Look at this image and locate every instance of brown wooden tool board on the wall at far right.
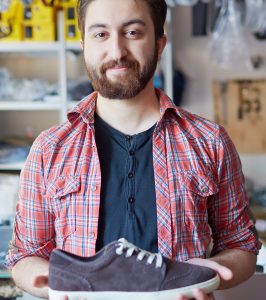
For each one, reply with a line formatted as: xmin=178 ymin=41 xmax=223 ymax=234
xmin=213 ymin=79 xmax=266 ymax=154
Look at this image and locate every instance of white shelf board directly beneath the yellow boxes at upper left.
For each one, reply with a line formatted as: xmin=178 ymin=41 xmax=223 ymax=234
xmin=0 ymin=41 xmax=59 ymax=53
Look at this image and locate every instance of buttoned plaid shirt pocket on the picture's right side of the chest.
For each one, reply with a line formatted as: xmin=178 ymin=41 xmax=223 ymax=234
xmin=179 ymin=172 xmax=218 ymax=235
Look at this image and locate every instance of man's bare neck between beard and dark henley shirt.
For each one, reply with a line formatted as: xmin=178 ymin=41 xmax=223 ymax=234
xmin=96 ymin=85 xmax=160 ymax=135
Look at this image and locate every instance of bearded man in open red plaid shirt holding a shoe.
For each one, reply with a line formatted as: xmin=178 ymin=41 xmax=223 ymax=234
xmin=5 ymin=0 xmax=259 ymax=299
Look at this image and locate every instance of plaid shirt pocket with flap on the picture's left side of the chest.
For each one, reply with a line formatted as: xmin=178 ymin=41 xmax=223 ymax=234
xmin=46 ymin=175 xmax=81 ymax=243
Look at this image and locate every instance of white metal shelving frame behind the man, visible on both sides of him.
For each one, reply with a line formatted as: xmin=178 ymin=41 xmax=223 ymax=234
xmin=0 ymin=8 xmax=173 ymax=172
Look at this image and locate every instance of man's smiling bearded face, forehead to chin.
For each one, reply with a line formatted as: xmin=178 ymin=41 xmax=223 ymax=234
xmin=83 ymin=0 xmax=162 ymax=99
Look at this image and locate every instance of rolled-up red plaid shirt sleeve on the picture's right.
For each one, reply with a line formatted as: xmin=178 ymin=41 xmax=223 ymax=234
xmin=209 ymin=127 xmax=261 ymax=255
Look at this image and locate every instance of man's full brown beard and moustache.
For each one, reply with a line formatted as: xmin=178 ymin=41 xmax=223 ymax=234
xmin=85 ymin=46 xmax=158 ymax=99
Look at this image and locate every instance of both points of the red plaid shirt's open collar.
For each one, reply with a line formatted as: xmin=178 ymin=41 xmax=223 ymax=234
xmin=67 ymin=88 xmax=183 ymax=124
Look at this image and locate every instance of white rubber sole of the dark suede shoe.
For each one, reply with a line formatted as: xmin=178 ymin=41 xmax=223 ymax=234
xmin=49 ymin=275 xmax=220 ymax=300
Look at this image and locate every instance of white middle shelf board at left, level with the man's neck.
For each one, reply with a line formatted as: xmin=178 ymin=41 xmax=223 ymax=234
xmin=0 ymin=101 xmax=62 ymax=111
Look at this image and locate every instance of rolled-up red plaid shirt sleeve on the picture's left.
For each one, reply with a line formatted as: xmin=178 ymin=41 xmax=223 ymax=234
xmin=6 ymin=133 xmax=55 ymax=268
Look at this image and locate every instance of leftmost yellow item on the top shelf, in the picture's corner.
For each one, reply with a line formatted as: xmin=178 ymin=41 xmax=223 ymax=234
xmin=0 ymin=0 xmax=23 ymax=42
